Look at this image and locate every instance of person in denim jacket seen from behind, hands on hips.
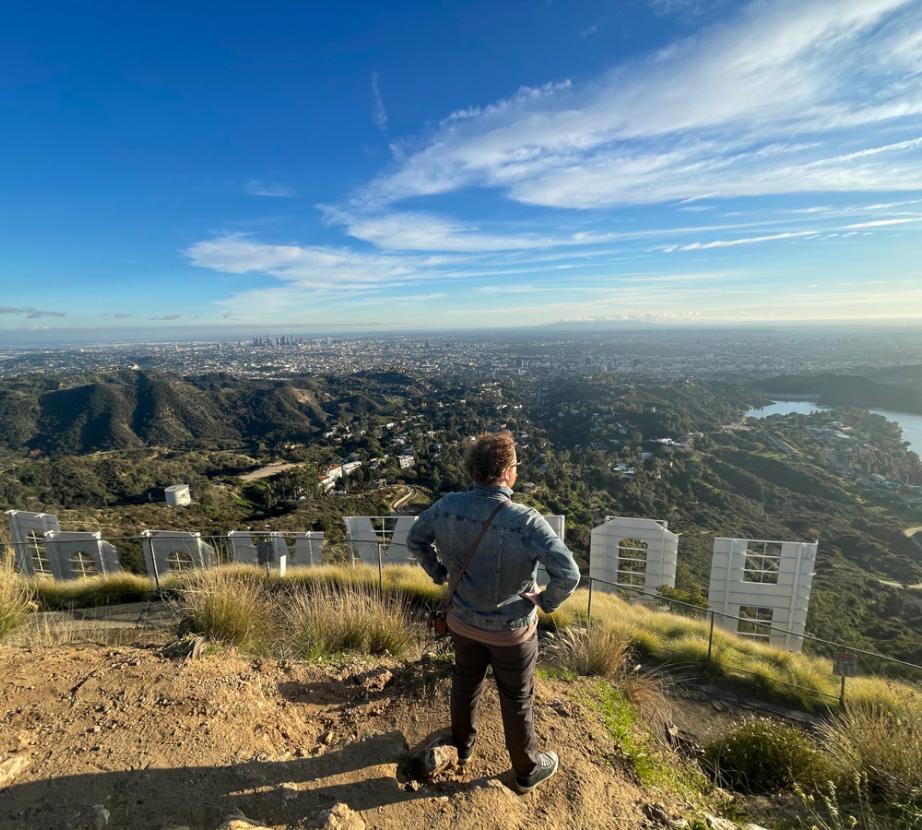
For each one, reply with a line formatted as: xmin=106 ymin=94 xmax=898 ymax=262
xmin=407 ymin=432 xmax=579 ymax=793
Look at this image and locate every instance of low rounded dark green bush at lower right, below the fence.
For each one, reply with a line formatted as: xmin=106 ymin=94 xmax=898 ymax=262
xmin=705 ymin=718 xmax=833 ymax=793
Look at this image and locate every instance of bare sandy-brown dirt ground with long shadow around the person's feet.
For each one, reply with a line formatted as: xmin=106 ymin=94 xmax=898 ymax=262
xmin=0 ymin=645 xmax=682 ymax=830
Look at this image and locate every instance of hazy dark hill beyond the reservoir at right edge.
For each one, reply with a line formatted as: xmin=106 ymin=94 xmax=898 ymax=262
xmin=759 ymin=366 xmax=922 ymax=415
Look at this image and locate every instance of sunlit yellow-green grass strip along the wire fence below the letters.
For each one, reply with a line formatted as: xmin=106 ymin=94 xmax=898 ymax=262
xmin=16 ymin=564 xmax=918 ymax=711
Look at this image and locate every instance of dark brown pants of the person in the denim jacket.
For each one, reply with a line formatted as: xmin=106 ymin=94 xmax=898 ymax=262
xmin=451 ymin=631 xmax=539 ymax=778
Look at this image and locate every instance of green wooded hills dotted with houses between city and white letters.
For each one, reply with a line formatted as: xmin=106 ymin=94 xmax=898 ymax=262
xmin=0 ymin=370 xmax=922 ymax=663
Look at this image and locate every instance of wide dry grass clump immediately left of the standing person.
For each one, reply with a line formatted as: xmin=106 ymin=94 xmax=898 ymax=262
xmin=285 ymin=587 xmax=416 ymax=660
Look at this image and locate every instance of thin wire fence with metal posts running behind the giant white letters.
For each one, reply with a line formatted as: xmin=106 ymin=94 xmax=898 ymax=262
xmin=7 ymin=532 xmax=922 ymax=703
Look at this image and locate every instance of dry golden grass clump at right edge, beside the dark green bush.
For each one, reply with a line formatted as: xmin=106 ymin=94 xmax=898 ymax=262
xmin=823 ymin=703 xmax=922 ymax=805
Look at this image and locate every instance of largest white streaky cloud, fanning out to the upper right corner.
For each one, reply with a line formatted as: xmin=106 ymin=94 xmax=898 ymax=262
xmin=358 ymin=0 xmax=922 ymax=208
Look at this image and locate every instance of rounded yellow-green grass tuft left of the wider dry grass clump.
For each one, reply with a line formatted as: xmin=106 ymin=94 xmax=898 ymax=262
xmin=177 ymin=570 xmax=274 ymax=650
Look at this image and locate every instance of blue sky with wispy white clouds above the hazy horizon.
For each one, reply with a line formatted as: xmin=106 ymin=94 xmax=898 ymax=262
xmin=0 ymin=0 xmax=922 ymax=336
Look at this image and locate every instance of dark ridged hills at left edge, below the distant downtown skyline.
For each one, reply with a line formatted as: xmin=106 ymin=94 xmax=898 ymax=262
xmin=0 ymin=372 xmax=344 ymax=455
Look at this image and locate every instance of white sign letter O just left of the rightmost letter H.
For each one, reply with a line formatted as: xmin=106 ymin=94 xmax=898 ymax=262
xmin=589 ymin=516 xmax=679 ymax=594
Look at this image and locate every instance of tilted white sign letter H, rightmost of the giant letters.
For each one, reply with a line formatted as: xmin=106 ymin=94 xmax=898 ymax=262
xmin=708 ymin=537 xmax=818 ymax=652
